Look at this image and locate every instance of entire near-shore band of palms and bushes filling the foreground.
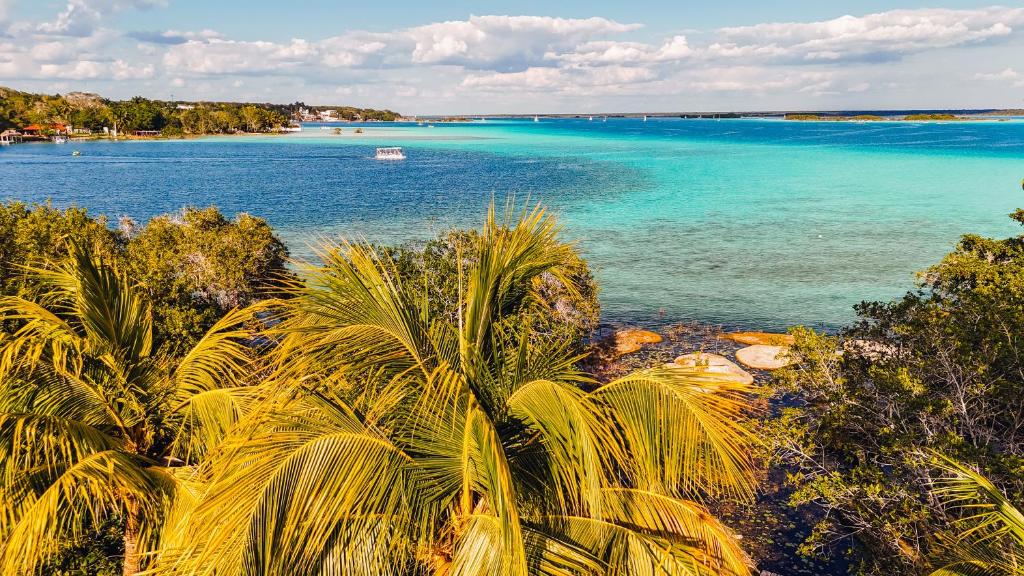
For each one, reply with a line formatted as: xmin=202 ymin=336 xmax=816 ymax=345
xmin=0 ymin=196 xmax=1024 ymax=576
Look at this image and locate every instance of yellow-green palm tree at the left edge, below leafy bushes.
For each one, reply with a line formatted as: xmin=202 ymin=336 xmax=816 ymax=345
xmin=0 ymin=243 xmax=250 ymax=576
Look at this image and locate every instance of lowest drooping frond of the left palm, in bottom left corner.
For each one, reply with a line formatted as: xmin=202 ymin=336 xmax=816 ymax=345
xmin=0 ymin=450 xmax=166 ymax=576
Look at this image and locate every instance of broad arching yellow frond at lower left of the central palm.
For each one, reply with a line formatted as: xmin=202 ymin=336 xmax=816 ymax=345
xmin=157 ymin=387 xmax=422 ymax=576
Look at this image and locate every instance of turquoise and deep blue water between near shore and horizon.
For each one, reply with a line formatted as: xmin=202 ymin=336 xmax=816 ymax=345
xmin=0 ymin=119 xmax=1024 ymax=329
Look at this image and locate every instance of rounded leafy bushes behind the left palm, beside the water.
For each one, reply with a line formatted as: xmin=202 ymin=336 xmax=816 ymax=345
xmin=0 ymin=202 xmax=292 ymax=349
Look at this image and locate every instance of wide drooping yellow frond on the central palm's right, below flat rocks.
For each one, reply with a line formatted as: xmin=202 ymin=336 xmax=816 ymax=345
xmin=591 ymin=368 xmax=756 ymax=498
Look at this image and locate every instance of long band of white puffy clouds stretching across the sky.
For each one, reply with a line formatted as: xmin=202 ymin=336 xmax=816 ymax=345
xmin=0 ymin=0 xmax=1024 ymax=109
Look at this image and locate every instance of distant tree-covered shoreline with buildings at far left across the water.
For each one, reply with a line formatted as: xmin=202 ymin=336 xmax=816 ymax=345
xmin=0 ymin=87 xmax=397 ymax=136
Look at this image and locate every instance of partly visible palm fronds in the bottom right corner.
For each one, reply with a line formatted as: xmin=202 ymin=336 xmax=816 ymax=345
xmin=932 ymin=455 xmax=1024 ymax=576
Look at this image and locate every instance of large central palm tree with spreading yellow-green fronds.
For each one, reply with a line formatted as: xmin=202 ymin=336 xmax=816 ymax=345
xmin=157 ymin=203 xmax=754 ymax=576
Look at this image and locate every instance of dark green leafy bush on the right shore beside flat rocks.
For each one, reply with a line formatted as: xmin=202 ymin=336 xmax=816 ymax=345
xmin=777 ymin=211 xmax=1024 ymax=575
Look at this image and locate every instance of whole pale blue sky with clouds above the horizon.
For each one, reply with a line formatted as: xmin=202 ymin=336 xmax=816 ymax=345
xmin=0 ymin=0 xmax=1024 ymax=115
